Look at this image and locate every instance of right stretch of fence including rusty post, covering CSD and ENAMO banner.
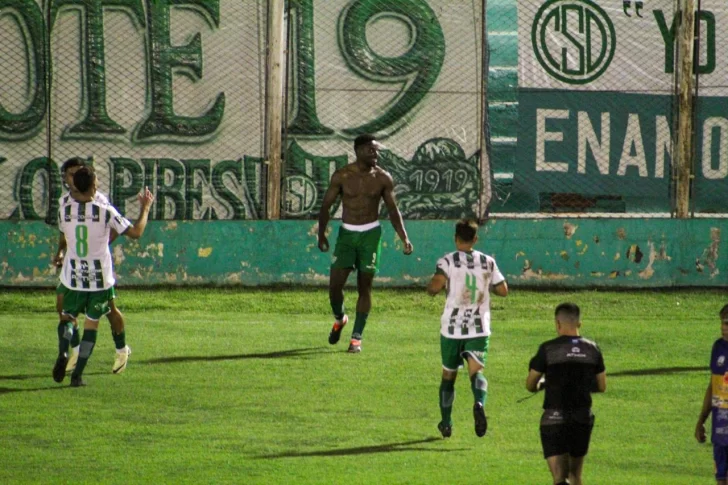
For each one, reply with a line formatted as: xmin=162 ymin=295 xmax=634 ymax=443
xmin=487 ymin=0 xmax=728 ymax=217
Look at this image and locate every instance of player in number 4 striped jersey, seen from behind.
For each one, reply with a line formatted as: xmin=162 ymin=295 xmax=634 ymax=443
xmin=427 ymin=220 xmax=508 ymax=438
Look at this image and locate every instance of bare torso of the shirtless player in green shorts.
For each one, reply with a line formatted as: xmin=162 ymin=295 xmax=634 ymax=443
xmin=337 ymin=163 xmax=391 ymax=225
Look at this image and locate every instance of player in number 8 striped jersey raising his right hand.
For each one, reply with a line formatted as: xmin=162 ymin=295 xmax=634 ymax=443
xmin=53 ymin=167 xmax=154 ymax=387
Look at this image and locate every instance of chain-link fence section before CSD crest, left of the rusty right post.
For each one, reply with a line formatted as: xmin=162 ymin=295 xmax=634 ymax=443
xmin=487 ymin=0 xmax=679 ymax=215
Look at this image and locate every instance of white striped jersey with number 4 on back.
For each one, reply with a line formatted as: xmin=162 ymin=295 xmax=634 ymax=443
xmin=437 ymin=251 xmax=505 ymax=339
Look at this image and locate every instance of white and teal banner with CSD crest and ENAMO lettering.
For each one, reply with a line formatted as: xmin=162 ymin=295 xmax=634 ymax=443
xmin=513 ymin=0 xmax=728 ymax=213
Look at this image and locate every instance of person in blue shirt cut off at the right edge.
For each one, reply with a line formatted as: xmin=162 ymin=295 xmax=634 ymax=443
xmin=695 ymin=305 xmax=728 ymax=485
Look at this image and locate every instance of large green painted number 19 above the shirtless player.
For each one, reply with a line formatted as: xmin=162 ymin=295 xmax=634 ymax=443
xmin=288 ymin=0 xmax=445 ymax=136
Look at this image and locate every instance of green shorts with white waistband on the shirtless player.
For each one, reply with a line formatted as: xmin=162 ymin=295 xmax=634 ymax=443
xmin=331 ymin=226 xmax=382 ymax=274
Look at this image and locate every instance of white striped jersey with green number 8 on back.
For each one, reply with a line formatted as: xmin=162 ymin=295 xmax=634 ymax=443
xmin=58 ymin=197 xmax=131 ymax=291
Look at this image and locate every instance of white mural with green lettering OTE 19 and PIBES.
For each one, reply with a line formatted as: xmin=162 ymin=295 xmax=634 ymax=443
xmin=0 ymin=0 xmax=481 ymax=220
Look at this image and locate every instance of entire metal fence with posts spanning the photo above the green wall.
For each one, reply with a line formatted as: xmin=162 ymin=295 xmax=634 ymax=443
xmin=0 ymin=0 xmax=728 ymax=221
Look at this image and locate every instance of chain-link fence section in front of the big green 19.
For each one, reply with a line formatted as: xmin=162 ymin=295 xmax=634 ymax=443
xmin=282 ymin=0 xmax=483 ymax=219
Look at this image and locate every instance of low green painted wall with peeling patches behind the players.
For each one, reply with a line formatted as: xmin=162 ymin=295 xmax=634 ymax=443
xmin=0 ymin=219 xmax=728 ymax=288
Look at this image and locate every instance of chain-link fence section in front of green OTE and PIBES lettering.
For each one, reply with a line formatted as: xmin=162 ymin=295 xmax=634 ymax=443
xmin=0 ymin=1 xmax=267 ymax=221
